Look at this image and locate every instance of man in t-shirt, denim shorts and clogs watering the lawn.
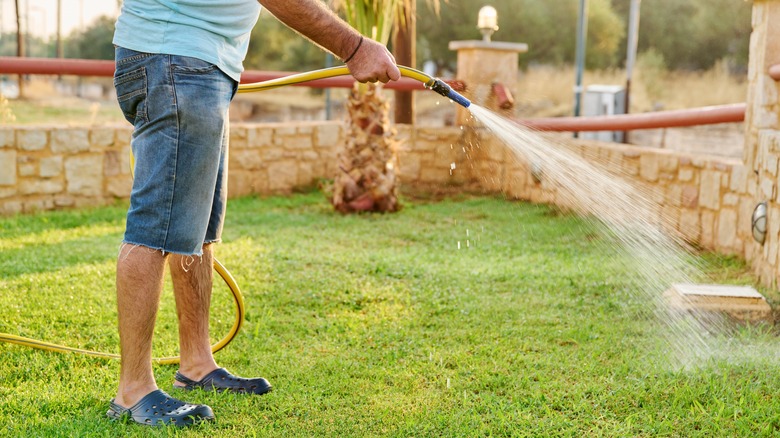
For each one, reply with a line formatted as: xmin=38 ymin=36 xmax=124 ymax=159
xmin=107 ymin=0 xmax=400 ymax=425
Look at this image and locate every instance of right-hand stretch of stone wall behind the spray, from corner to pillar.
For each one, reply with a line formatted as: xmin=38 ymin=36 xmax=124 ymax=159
xmin=475 ymin=132 xmax=755 ymax=257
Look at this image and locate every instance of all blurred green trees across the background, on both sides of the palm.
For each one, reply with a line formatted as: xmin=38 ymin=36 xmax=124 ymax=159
xmin=0 ymin=0 xmax=752 ymax=72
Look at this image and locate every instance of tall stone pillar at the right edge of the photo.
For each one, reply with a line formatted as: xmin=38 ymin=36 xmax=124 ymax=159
xmin=744 ymin=0 xmax=780 ymax=287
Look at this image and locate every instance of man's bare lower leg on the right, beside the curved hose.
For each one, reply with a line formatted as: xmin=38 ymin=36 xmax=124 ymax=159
xmin=169 ymin=245 xmax=219 ymax=386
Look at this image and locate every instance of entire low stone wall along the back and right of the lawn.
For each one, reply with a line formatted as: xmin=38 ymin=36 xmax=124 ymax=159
xmin=0 ymin=122 xmax=756 ymax=258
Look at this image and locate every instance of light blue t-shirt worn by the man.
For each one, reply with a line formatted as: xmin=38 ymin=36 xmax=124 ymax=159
xmin=114 ymin=0 xmax=260 ymax=81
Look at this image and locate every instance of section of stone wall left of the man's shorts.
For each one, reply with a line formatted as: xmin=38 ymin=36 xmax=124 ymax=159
xmin=0 ymin=126 xmax=131 ymax=215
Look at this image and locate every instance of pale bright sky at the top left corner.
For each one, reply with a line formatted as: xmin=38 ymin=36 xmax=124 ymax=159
xmin=0 ymin=0 xmax=118 ymax=37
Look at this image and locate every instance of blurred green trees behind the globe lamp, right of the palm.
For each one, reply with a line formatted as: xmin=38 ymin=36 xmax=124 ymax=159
xmin=417 ymin=0 xmax=752 ymax=69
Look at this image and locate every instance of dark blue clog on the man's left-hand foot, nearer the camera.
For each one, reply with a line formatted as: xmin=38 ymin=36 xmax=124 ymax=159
xmin=106 ymin=389 xmax=214 ymax=426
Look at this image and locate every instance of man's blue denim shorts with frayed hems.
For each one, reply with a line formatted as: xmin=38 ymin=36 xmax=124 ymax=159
xmin=114 ymin=47 xmax=238 ymax=255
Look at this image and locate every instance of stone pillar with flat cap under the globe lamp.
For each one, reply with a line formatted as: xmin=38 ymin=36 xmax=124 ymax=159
xmin=449 ymin=40 xmax=528 ymax=125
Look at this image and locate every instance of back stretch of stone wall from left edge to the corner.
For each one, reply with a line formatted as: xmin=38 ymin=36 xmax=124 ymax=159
xmin=0 ymin=122 xmax=470 ymax=215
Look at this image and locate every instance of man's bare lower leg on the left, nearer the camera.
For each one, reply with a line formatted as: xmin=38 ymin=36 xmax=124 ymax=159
xmin=114 ymin=244 xmax=166 ymax=408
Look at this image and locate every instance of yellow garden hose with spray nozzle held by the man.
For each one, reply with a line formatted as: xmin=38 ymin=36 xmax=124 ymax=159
xmin=0 ymin=65 xmax=471 ymax=364
